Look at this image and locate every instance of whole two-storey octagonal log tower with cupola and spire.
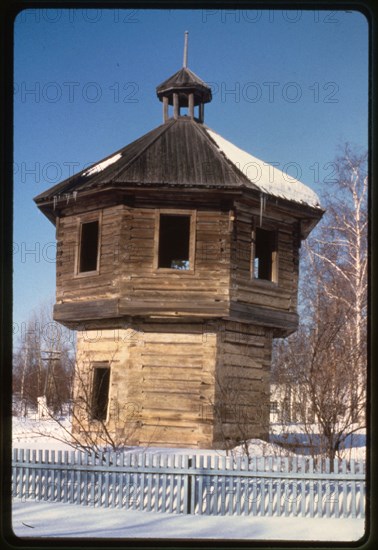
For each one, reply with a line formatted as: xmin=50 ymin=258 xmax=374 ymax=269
xmin=35 ymin=34 xmax=322 ymax=448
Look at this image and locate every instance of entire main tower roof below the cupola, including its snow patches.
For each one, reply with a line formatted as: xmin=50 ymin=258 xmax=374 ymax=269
xmin=34 ymin=117 xmax=320 ymax=219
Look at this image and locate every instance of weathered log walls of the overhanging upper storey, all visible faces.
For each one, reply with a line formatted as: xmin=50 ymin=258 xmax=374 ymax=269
xmin=55 ymin=203 xmax=298 ymax=334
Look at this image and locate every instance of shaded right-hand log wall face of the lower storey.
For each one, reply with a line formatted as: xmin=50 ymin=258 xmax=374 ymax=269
xmin=214 ymin=321 xmax=272 ymax=448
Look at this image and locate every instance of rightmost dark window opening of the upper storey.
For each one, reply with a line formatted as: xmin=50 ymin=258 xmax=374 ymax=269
xmin=252 ymin=228 xmax=277 ymax=282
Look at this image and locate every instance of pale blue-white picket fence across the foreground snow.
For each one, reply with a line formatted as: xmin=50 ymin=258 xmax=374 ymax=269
xmin=12 ymin=449 xmax=365 ymax=518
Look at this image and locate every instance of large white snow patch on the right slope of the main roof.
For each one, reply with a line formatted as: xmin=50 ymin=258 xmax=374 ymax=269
xmin=206 ymin=128 xmax=320 ymax=208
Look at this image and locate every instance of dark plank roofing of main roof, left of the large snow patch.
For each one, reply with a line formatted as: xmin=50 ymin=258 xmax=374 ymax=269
xmin=34 ymin=117 xmax=258 ymax=204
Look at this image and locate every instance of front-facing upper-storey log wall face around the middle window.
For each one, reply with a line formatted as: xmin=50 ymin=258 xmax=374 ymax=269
xmin=120 ymin=208 xmax=229 ymax=315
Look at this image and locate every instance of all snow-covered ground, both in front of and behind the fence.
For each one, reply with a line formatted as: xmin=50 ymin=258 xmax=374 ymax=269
xmin=12 ymin=417 xmax=365 ymax=541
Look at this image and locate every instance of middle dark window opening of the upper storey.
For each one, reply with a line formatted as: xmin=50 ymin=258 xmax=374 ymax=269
xmin=158 ymin=214 xmax=190 ymax=270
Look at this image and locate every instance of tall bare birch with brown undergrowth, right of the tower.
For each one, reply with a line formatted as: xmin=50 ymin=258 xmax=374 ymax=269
xmin=274 ymin=145 xmax=368 ymax=459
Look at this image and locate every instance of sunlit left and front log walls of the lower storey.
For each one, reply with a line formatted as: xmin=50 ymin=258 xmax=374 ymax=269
xmin=73 ymin=323 xmax=216 ymax=448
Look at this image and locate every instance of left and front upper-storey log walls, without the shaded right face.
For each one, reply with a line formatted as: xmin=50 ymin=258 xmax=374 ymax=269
xmin=56 ymin=205 xmax=230 ymax=321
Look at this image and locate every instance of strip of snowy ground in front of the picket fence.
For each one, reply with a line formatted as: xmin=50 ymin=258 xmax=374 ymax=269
xmin=13 ymin=499 xmax=364 ymax=541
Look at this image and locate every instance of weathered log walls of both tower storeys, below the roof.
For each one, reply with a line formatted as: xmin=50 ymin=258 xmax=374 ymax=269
xmin=54 ymin=197 xmax=308 ymax=448
